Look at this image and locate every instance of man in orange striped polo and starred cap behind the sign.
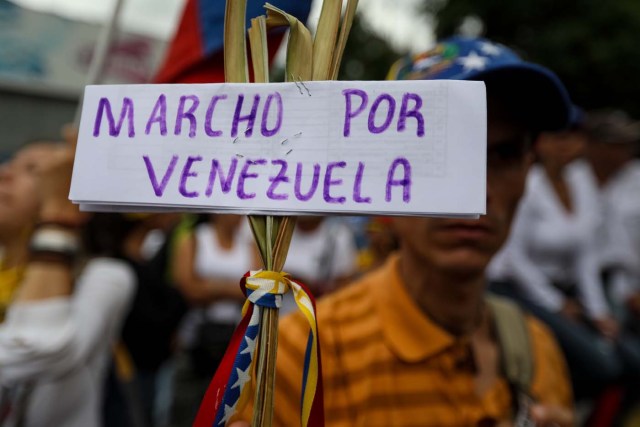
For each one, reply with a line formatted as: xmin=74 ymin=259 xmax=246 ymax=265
xmin=232 ymin=38 xmax=573 ymax=427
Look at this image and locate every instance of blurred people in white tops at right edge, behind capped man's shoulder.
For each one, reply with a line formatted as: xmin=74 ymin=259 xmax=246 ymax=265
xmin=487 ymin=110 xmax=640 ymax=425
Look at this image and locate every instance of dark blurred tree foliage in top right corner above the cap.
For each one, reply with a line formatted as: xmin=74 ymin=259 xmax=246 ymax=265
xmin=424 ymin=0 xmax=640 ymax=118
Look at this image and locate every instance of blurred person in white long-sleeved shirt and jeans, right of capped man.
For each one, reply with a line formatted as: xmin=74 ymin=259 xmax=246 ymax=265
xmin=488 ymin=130 xmax=622 ymax=397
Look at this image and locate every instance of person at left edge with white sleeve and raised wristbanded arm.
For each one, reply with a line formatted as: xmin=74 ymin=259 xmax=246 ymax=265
xmin=0 ymin=143 xmax=135 ymax=427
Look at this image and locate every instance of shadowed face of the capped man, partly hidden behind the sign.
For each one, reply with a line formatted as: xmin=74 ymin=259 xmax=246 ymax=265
xmin=394 ymin=109 xmax=532 ymax=275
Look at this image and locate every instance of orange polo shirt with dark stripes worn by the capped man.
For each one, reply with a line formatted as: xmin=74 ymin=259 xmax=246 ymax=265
xmin=234 ymin=257 xmax=571 ymax=427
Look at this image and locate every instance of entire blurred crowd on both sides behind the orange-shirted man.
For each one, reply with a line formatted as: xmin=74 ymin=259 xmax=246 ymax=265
xmin=0 ymin=44 xmax=640 ymax=427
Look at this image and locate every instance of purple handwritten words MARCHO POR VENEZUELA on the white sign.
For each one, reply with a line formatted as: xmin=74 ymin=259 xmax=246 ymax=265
xmin=93 ymin=89 xmax=425 ymax=204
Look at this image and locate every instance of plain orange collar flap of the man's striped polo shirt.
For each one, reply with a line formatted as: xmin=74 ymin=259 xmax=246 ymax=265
xmin=373 ymin=255 xmax=456 ymax=362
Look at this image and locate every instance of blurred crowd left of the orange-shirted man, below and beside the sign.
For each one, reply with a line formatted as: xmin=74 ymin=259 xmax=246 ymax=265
xmin=0 ymin=137 xmax=370 ymax=426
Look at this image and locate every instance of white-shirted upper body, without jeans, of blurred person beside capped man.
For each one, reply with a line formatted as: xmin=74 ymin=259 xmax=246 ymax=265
xmin=492 ymin=129 xmax=616 ymax=322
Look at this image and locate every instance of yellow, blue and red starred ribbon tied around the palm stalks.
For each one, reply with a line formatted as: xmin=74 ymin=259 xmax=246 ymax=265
xmin=193 ymin=270 xmax=324 ymax=427
